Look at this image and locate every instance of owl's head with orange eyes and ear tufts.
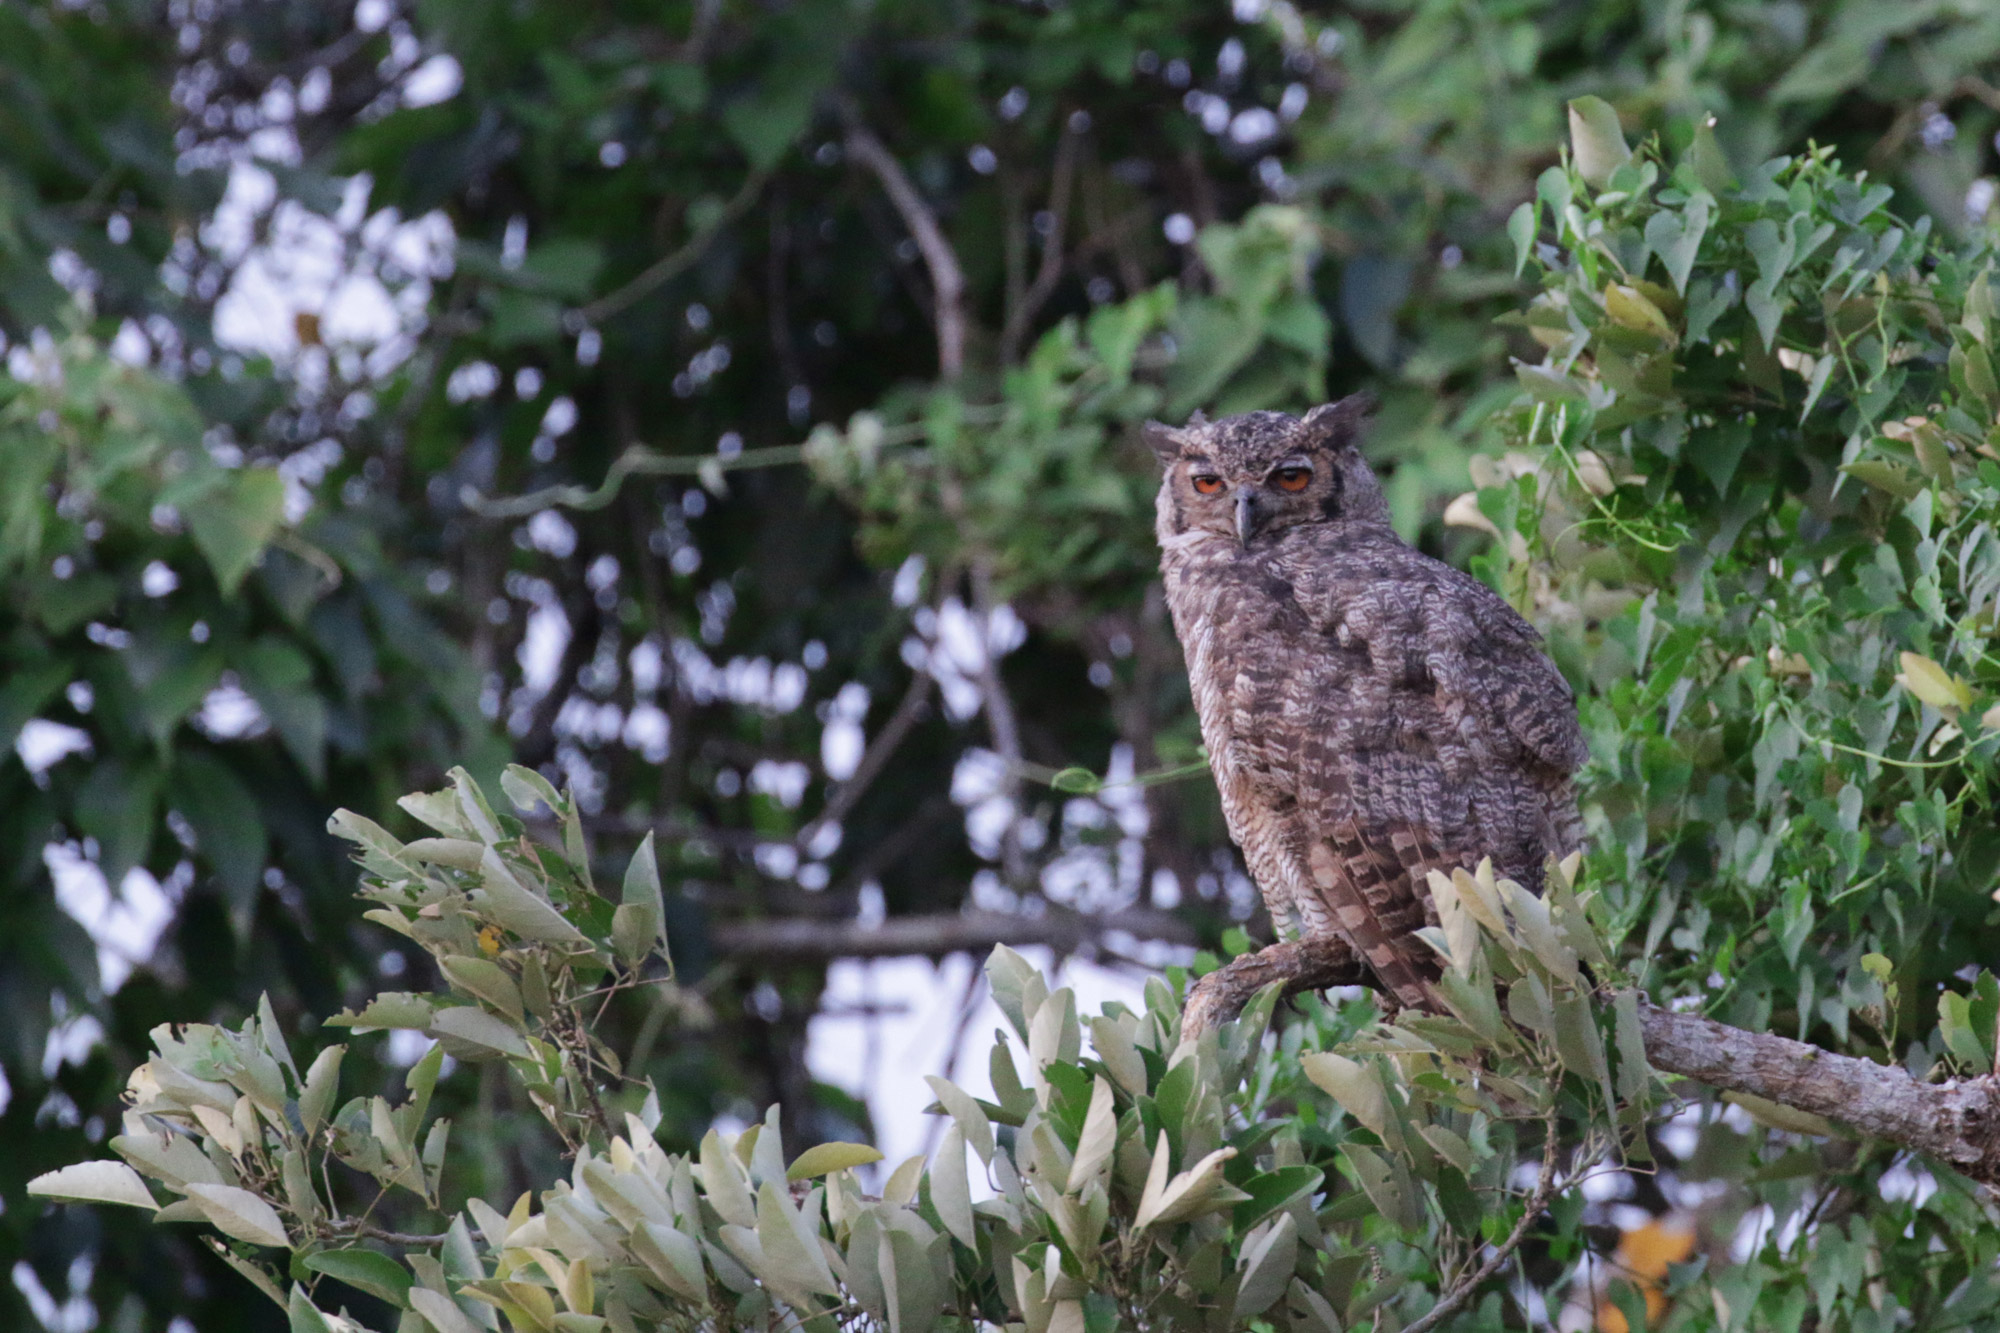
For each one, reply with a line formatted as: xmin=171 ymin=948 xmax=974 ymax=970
xmin=1146 ymin=394 xmax=1388 ymax=548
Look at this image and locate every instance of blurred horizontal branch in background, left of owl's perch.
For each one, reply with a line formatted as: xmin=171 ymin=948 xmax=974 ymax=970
xmin=714 ymin=909 xmax=1196 ymax=963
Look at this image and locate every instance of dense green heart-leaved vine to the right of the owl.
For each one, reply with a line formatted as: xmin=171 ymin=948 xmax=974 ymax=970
xmin=1454 ymin=100 xmax=2000 ymax=1329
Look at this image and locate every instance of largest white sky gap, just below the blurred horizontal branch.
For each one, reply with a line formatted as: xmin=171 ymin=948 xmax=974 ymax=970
xmin=806 ymin=949 xmax=1146 ymax=1199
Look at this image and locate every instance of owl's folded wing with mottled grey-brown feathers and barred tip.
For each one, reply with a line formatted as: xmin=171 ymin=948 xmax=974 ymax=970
xmin=1290 ymin=538 xmax=1586 ymax=1007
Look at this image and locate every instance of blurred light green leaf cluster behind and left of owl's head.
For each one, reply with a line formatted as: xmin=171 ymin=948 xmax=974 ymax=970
xmin=808 ymin=204 xmax=1328 ymax=618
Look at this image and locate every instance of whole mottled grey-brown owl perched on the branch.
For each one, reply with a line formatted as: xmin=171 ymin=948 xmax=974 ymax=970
xmin=1146 ymin=398 xmax=1586 ymax=1009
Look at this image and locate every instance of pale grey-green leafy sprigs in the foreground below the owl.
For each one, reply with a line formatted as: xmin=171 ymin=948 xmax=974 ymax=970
xmin=30 ymin=767 xmax=1650 ymax=1333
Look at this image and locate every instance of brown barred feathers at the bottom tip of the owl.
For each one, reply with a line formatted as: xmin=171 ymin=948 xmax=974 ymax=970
xmin=1310 ymin=819 xmax=1460 ymax=1013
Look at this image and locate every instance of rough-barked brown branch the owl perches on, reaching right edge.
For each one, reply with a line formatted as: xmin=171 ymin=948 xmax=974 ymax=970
xmin=1184 ymin=939 xmax=2000 ymax=1185
